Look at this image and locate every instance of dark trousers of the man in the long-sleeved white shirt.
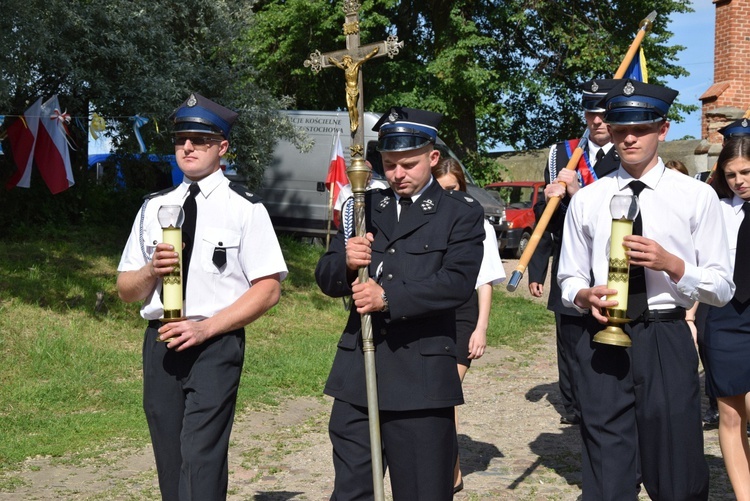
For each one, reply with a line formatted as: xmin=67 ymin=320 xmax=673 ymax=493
xmin=576 ymin=316 xmax=708 ymax=501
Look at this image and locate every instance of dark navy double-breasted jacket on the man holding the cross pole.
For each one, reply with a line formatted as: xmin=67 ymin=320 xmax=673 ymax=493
xmin=315 ymin=180 xmax=485 ymax=411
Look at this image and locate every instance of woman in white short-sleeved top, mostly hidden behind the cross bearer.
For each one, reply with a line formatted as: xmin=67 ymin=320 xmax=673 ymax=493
xmin=432 ymin=156 xmax=505 ymax=493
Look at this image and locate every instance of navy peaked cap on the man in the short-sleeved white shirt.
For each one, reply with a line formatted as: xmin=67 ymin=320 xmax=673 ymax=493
xmin=170 ymin=93 xmax=237 ymax=139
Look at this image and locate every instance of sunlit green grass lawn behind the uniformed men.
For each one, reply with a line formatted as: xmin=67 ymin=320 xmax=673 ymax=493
xmin=0 ymin=228 xmax=554 ymax=472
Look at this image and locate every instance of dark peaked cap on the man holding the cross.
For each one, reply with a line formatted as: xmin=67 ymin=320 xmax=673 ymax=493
xmin=372 ymin=106 xmax=443 ymax=151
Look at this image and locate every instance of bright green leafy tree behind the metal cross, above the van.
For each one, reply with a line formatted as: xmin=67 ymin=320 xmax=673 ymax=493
xmin=245 ymin=0 xmax=690 ymax=172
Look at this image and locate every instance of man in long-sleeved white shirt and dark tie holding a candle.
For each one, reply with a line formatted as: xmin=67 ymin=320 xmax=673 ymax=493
xmin=557 ymin=79 xmax=734 ymax=501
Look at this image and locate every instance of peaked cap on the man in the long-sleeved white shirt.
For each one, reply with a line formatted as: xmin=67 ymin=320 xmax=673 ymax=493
xmin=599 ymin=78 xmax=679 ymax=125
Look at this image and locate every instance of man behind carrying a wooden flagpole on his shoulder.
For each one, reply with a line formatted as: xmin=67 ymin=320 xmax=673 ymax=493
xmin=529 ymin=79 xmax=620 ymax=424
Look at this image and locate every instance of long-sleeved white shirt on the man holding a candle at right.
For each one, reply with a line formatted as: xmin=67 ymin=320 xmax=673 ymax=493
xmin=557 ymin=159 xmax=734 ymax=312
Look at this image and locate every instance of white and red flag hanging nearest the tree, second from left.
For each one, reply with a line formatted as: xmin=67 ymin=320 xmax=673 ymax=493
xmin=34 ymin=95 xmax=75 ymax=195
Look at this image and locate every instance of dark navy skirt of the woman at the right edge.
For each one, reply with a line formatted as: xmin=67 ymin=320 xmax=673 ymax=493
xmin=703 ymin=299 xmax=750 ymax=397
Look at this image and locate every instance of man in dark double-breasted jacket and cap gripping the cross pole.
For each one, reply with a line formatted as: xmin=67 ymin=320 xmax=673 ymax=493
xmin=315 ymin=107 xmax=485 ymax=501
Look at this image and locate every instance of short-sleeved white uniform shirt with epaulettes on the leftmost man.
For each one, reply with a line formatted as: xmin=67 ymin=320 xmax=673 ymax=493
xmin=117 ymin=170 xmax=287 ymax=320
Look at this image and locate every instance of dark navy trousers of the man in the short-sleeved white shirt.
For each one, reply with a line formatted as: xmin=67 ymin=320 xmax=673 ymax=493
xmin=143 ymin=320 xmax=245 ymax=501
